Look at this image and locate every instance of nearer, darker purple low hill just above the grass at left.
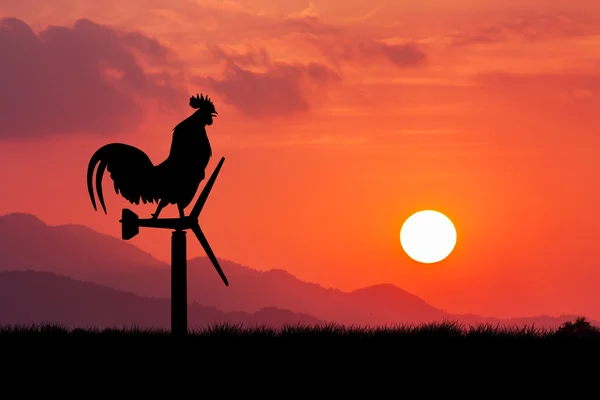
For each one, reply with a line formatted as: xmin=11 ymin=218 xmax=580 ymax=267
xmin=0 ymin=271 xmax=323 ymax=329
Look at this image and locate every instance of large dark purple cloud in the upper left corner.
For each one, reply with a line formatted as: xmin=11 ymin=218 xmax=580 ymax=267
xmin=0 ymin=18 xmax=186 ymax=138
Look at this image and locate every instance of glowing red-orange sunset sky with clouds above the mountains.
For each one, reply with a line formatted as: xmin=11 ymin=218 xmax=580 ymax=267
xmin=0 ymin=0 xmax=600 ymax=319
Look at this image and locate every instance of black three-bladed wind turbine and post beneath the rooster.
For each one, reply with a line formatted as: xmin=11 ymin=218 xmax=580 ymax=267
xmin=119 ymin=157 xmax=229 ymax=336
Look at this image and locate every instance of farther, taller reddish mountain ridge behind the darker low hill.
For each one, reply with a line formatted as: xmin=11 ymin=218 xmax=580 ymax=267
xmin=0 ymin=213 xmax=592 ymax=327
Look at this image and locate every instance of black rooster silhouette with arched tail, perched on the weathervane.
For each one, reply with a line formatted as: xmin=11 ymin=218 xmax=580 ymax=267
xmin=87 ymin=94 xmax=218 ymax=219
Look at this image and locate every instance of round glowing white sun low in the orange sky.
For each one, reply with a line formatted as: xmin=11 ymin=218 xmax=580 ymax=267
xmin=400 ymin=210 xmax=456 ymax=264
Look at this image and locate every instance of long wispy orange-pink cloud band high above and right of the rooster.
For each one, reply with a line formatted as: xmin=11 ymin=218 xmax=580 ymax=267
xmin=177 ymin=12 xmax=428 ymax=70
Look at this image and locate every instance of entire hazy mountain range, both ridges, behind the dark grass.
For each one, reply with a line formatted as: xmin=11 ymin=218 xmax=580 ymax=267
xmin=0 ymin=213 xmax=592 ymax=327
